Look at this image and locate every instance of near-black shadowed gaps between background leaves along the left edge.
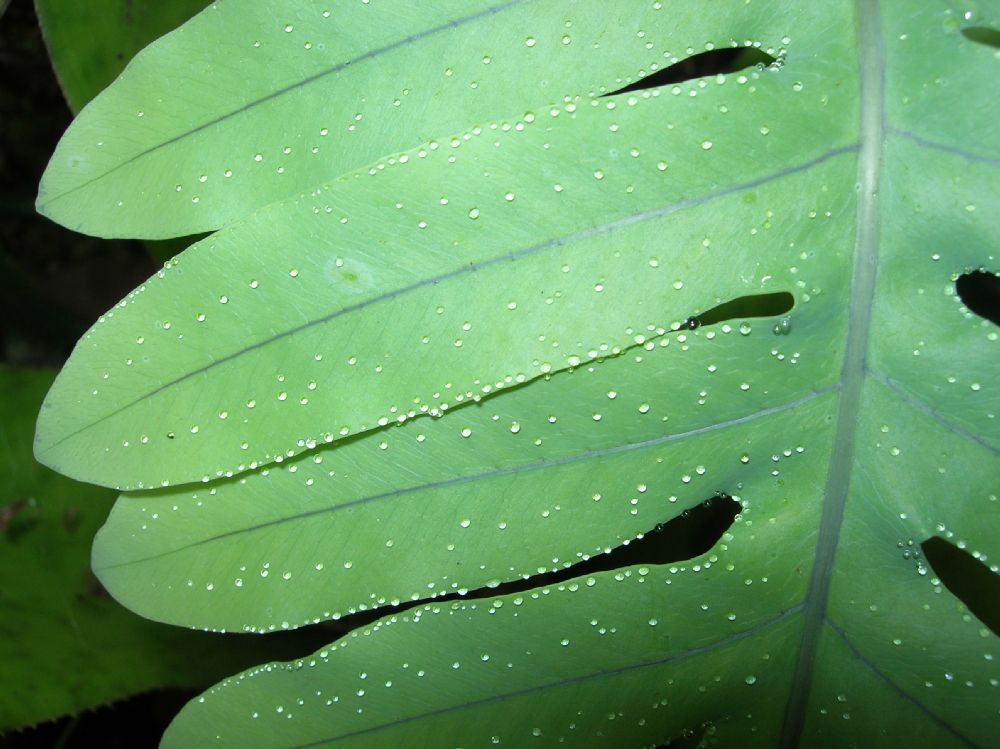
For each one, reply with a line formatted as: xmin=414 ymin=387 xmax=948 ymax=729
xmin=0 ymin=0 xmax=179 ymax=749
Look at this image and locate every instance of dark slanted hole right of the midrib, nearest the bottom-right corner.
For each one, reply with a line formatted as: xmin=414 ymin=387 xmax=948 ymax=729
xmin=920 ymin=536 xmax=1000 ymax=635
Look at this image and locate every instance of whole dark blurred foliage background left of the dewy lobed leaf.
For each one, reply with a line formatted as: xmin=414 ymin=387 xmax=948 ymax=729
xmin=0 ymin=0 xmax=310 ymax=749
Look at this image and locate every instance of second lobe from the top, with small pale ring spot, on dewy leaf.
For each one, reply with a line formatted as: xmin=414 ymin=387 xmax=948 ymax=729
xmin=37 ymin=2 xmax=854 ymax=489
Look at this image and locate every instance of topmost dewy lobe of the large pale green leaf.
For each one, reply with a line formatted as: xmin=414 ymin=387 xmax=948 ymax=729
xmin=38 ymin=0 xmax=780 ymax=239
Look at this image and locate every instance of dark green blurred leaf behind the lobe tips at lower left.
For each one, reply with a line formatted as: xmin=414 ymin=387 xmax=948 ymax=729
xmin=0 ymin=368 xmax=320 ymax=731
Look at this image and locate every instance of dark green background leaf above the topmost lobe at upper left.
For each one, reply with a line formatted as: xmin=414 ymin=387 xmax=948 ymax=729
xmin=33 ymin=0 xmax=208 ymax=112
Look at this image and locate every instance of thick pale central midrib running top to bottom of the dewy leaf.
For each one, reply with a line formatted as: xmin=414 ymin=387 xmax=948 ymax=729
xmin=781 ymin=0 xmax=885 ymax=749
